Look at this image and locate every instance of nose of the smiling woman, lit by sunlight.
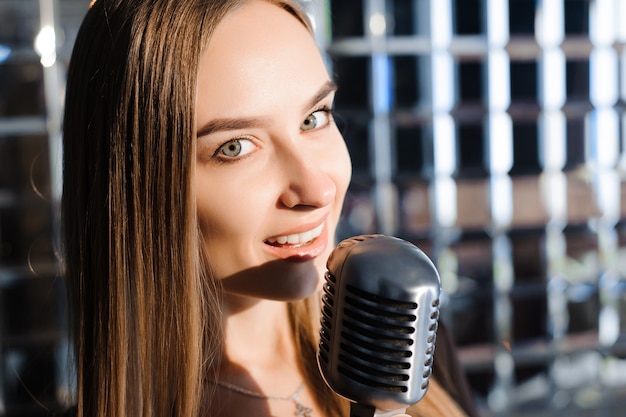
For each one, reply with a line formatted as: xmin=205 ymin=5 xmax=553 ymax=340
xmin=279 ymin=151 xmax=337 ymax=208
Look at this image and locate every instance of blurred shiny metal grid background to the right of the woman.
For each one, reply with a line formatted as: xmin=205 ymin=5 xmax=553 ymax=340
xmin=318 ymin=0 xmax=626 ymax=415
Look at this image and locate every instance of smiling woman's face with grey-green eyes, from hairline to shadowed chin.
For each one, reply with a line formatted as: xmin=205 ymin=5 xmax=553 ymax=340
xmin=195 ymin=1 xmax=351 ymax=300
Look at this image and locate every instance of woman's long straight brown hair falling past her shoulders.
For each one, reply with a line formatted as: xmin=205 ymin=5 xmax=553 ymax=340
xmin=62 ymin=0 xmax=343 ymax=417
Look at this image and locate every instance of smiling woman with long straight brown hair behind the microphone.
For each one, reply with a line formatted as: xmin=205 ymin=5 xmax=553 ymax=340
xmin=63 ymin=0 xmax=471 ymax=417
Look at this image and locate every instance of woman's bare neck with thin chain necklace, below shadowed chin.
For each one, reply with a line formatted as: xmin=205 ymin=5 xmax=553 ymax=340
xmin=210 ymin=296 xmax=323 ymax=417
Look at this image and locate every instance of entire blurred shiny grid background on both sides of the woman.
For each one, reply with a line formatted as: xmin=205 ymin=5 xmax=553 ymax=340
xmin=0 ymin=0 xmax=626 ymax=417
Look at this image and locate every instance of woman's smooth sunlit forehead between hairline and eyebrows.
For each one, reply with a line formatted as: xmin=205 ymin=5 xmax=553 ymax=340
xmin=198 ymin=0 xmax=329 ymax=117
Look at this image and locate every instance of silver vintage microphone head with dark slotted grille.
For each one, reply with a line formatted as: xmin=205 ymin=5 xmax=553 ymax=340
xmin=317 ymin=235 xmax=441 ymax=410
